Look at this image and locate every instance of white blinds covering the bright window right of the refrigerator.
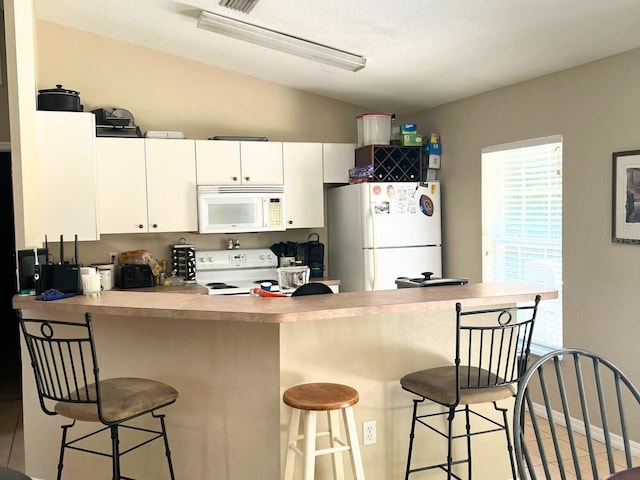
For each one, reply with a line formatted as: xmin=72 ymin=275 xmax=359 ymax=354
xmin=482 ymin=136 xmax=562 ymax=354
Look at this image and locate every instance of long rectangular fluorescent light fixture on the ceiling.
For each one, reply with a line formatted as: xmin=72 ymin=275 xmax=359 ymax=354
xmin=198 ymin=10 xmax=367 ymax=72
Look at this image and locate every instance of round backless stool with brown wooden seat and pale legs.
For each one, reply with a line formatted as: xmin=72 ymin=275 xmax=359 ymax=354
xmin=282 ymin=383 xmax=364 ymax=480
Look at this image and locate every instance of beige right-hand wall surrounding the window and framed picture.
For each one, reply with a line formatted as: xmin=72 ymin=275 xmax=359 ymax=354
xmin=415 ymin=50 xmax=640 ymax=384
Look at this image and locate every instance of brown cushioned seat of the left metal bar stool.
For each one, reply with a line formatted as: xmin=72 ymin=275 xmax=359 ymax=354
xmin=55 ymin=378 xmax=178 ymax=423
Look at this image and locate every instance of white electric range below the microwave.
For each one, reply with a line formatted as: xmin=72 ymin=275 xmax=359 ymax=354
xmin=196 ymin=248 xmax=278 ymax=296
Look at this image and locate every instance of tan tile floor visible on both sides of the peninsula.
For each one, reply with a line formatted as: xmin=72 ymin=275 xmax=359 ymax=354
xmin=0 ymin=400 xmax=640 ymax=480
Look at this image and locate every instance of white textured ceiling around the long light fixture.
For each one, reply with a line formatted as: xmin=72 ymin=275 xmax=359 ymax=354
xmin=34 ymin=0 xmax=640 ymax=114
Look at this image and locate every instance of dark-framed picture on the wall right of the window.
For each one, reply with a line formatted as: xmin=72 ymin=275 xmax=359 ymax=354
xmin=611 ymin=150 xmax=640 ymax=244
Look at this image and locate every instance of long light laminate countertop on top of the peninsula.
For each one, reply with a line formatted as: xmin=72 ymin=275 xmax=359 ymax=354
xmin=13 ymin=283 xmax=558 ymax=323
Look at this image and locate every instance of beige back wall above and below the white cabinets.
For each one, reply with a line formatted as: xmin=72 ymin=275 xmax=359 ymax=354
xmin=25 ymin=21 xmax=366 ymax=264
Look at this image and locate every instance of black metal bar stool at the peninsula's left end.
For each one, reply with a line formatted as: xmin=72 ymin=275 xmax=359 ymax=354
xmin=18 ymin=311 xmax=178 ymax=480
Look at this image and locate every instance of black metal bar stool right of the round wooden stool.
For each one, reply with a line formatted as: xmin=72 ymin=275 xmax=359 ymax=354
xmin=400 ymin=295 xmax=540 ymax=480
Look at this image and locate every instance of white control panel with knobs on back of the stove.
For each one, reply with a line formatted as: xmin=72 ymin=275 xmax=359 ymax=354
xmin=196 ymin=248 xmax=278 ymax=271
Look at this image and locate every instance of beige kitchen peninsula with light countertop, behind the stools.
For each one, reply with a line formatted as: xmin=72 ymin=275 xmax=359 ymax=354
xmin=13 ymin=284 xmax=557 ymax=480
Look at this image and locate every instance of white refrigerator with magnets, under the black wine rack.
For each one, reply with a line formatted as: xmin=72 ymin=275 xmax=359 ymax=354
xmin=327 ymin=181 xmax=442 ymax=292
